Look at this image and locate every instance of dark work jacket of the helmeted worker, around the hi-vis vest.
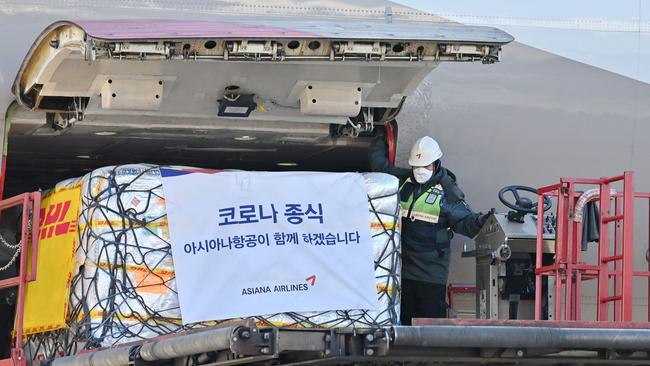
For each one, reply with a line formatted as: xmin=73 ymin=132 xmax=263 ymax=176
xmin=369 ymin=140 xmax=481 ymax=285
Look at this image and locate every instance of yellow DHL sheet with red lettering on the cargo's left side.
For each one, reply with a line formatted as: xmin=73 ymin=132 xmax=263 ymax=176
xmin=24 ymin=183 xmax=81 ymax=334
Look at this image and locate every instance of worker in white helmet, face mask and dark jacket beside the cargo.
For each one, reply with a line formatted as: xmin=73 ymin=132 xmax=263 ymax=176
xmin=369 ymin=126 xmax=494 ymax=325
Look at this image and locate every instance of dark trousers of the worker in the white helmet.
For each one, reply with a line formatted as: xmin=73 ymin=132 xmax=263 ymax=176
xmin=400 ymin=278 xmax=447 ymax=325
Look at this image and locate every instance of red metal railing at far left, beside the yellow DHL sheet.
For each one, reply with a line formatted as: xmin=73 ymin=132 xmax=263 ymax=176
xmin=0 ymin=192 xmax=41 ymax=366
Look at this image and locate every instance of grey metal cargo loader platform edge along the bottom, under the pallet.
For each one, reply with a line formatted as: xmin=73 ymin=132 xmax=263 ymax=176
xmin=43 ymin=319 xmax=650 ymax=366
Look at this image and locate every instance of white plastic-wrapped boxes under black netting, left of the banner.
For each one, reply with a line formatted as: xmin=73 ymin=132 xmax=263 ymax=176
xmin=71 ymin=165 xmax=180 ymax=345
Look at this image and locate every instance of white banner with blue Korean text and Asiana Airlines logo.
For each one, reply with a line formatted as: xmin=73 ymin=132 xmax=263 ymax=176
xmin=161 ymin=169 xmax=379 ymax=324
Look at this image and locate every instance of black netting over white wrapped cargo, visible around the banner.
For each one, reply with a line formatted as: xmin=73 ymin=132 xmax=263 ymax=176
xmin=28 ymin=164 xmax=401 ymax=358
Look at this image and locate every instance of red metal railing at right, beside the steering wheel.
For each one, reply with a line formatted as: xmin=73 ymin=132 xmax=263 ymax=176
xmin=535 ymin=172 xmax=650 ymax=322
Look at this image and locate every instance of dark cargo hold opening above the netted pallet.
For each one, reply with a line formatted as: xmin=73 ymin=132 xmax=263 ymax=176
xmin=4 ymin=103 xmax=371 ymax=197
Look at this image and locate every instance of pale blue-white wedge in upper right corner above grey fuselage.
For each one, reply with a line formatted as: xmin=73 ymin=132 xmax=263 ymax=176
xmin=397 ymin=0 xmax=650 ymax=83
